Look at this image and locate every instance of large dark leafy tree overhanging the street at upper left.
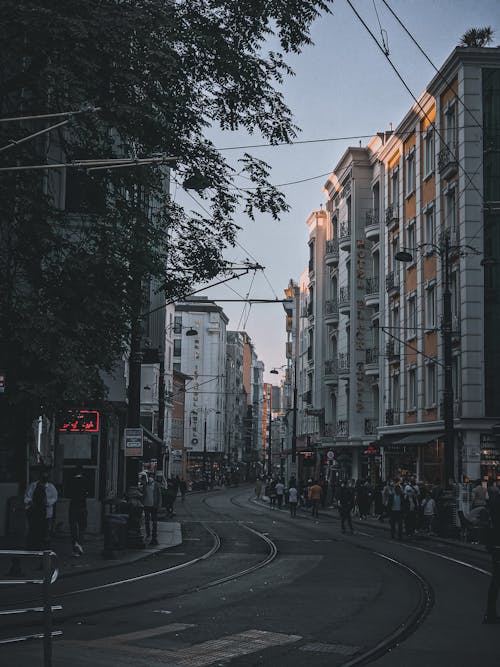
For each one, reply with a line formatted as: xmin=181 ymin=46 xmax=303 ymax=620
xmin=0 ymin=0 xmax=328 ymax=480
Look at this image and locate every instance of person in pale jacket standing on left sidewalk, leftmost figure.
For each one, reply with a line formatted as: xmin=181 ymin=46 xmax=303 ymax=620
xmin=24 ymin=470 xmax=57 ymax=549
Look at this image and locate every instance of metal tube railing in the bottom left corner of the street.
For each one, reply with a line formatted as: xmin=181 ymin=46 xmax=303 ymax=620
xmin=0 ymin=550 xmax=62 ymax=667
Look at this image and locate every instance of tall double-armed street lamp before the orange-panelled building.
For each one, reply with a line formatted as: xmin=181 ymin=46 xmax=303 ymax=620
xmin=394 ymin=231 xmax=479 ymax=486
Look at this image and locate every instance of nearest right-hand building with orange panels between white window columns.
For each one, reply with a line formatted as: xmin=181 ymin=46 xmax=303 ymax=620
xmin=378 ymin=48 xmax=500 ymax=481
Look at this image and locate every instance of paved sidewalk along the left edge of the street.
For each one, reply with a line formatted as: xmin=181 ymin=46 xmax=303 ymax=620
xmin=0 ymin=520 xmax=182 ymax=578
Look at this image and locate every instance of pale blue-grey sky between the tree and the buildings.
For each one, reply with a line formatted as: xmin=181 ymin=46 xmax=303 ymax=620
xmin=174 ymin=0 xmax=500 ymax=384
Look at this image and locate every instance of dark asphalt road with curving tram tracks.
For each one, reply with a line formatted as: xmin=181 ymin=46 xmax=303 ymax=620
xmin=0 ymin=487 xmax=500 ymax=667
